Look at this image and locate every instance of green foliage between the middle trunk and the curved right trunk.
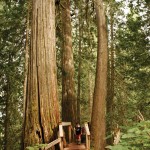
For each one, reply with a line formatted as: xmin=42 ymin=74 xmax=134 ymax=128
xmin=72 ymin=0 xmax=97 ymax=123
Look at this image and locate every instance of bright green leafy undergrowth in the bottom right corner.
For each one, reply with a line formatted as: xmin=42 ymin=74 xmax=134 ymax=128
xmin=106 ymin=121 xmax=150 ymax=150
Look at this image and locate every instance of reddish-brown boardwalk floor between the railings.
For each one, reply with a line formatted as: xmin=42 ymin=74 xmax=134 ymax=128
xmin=64 ymin=143 xmax=87 ymax=150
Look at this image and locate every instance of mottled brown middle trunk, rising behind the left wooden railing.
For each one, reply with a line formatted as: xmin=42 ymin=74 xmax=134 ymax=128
xmin=61 ymin=0 xmax=76 ymax=124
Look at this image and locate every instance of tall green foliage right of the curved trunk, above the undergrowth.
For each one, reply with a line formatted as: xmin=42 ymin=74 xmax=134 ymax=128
xmin=107 ymin=0 xmax=150 ymax=129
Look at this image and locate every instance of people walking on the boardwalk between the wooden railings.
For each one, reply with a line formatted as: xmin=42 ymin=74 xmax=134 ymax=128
xmin=74 ymin=123 xmax=85 ymax=144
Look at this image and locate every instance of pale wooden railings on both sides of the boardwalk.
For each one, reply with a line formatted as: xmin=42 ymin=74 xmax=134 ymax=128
xmin=39 ymin=122 xmax=90 ymax=150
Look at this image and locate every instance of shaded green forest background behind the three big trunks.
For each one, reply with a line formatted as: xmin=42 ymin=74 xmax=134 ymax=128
xmin=0 ymin=0 xmax=150 ymax=150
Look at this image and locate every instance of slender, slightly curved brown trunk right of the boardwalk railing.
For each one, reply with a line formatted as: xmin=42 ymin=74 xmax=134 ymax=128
xmin=92 ymin=0 xmax=108 ymax=150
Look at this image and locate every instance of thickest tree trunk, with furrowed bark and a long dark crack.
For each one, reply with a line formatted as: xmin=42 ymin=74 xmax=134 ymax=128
xmin=24 ymin=0 xmax=59 ymax=149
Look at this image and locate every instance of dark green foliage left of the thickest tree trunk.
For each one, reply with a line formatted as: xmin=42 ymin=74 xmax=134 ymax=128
xmin=0 ymin=2 xmax=26 ymax=150
